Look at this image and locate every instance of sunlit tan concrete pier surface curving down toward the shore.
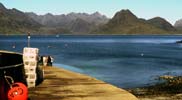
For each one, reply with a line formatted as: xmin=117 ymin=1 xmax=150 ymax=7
xmin=29 ymin=67 xmax=138 ymax=100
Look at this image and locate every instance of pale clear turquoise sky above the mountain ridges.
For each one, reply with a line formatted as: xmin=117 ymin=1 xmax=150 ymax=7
xmin=0 ymin=0 xmax=182 ymax=24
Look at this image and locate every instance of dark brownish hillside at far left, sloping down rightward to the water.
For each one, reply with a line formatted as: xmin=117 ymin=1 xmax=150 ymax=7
xmin=0 ymin=3 xmax=41 ymax=34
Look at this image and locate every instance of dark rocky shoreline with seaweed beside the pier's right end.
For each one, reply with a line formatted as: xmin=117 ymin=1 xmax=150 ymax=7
xmin=128 ymin=75 xmax=182 ymax=100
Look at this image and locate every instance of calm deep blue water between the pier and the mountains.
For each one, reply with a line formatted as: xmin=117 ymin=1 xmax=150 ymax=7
xmin=0 ymin=35 xmax=182 ymax=88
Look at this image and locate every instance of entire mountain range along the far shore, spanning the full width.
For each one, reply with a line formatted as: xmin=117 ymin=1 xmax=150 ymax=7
xmin=0 ymin=3 xmax=182 ymax=35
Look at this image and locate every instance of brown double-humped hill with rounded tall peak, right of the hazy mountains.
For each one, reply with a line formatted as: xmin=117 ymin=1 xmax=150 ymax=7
xmin=93 ymin=10 xmax=175 ymax=34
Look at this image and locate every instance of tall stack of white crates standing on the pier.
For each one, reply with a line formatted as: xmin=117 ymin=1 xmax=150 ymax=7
xmin=23 ymin=47 xmax=39 ymax=87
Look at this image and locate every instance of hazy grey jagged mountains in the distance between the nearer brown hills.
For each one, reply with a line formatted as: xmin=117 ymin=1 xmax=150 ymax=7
xmin=26 ymin=12 xmax=109 ymax=34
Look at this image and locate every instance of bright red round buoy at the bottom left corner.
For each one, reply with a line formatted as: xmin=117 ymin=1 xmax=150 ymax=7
xmin=8 ymin=83 xmax=28 ymax=100
